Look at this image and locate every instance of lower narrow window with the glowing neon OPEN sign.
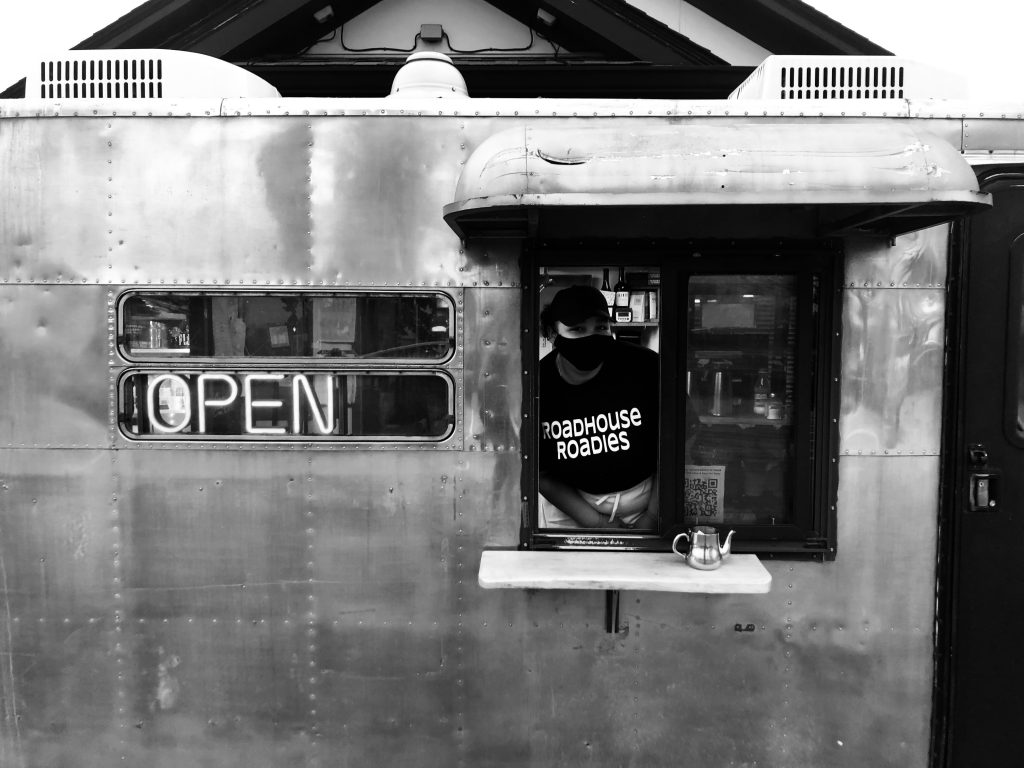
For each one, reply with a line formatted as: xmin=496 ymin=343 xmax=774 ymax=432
xmin=121 ymin=370 xmax=455 ymax=440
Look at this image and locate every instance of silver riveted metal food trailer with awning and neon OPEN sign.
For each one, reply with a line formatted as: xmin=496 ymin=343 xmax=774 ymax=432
xmin=0 ymin=50 xmax=1024 ymax=768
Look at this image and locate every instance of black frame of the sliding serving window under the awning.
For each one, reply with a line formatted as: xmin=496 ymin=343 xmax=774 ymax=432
xmin=520 ymin=240 xmax=843 ymax=560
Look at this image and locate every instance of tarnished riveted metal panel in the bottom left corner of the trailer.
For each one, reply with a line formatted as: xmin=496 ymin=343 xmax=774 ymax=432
xmin=0 ymin=447 xmax=121 ymax=766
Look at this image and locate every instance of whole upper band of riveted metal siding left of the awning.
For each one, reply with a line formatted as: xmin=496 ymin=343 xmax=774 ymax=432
xmin=3 ymin=116 xmax=532 ymax=286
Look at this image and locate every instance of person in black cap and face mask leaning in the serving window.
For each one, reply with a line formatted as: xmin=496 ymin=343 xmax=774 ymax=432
xmin=540 ymin=286 xmax=658 ymax=529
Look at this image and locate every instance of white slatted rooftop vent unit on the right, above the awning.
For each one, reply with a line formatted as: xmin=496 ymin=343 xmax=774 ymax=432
xmin=729 ymin=55 xmax=966 ymax=101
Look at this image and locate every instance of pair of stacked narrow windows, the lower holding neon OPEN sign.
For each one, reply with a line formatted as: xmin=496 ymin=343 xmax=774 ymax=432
xmin=118 ymin=291 xmax=460 ymax=442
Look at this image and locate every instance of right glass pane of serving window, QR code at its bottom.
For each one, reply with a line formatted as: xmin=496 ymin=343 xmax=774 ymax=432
xmin=680 ymin=274 xmax=797 ymax=525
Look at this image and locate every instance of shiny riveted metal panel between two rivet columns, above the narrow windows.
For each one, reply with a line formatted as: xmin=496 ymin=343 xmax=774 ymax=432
xmin=106 ymin=118 xmax=310 ymax=285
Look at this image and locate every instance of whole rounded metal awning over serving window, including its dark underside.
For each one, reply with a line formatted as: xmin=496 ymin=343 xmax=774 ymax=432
xmin=444 ymin=119 xmax=991 ymax=239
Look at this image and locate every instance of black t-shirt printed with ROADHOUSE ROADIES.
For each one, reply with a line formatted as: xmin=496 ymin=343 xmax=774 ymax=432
xmin=540 ymin=341 xmax=658 ymax=494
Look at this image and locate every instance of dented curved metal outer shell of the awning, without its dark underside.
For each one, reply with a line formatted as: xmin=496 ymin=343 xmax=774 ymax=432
xmin=444 ymin=120 xmax=991 ymax=232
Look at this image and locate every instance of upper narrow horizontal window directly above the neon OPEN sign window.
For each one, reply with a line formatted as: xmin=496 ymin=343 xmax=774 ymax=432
xmin=121 ymin=293 xmax=455 ymax=360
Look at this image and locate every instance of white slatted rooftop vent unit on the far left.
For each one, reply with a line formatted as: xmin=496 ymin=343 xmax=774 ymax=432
xmin=25 ymin=48 xmax=281 ymax=99
